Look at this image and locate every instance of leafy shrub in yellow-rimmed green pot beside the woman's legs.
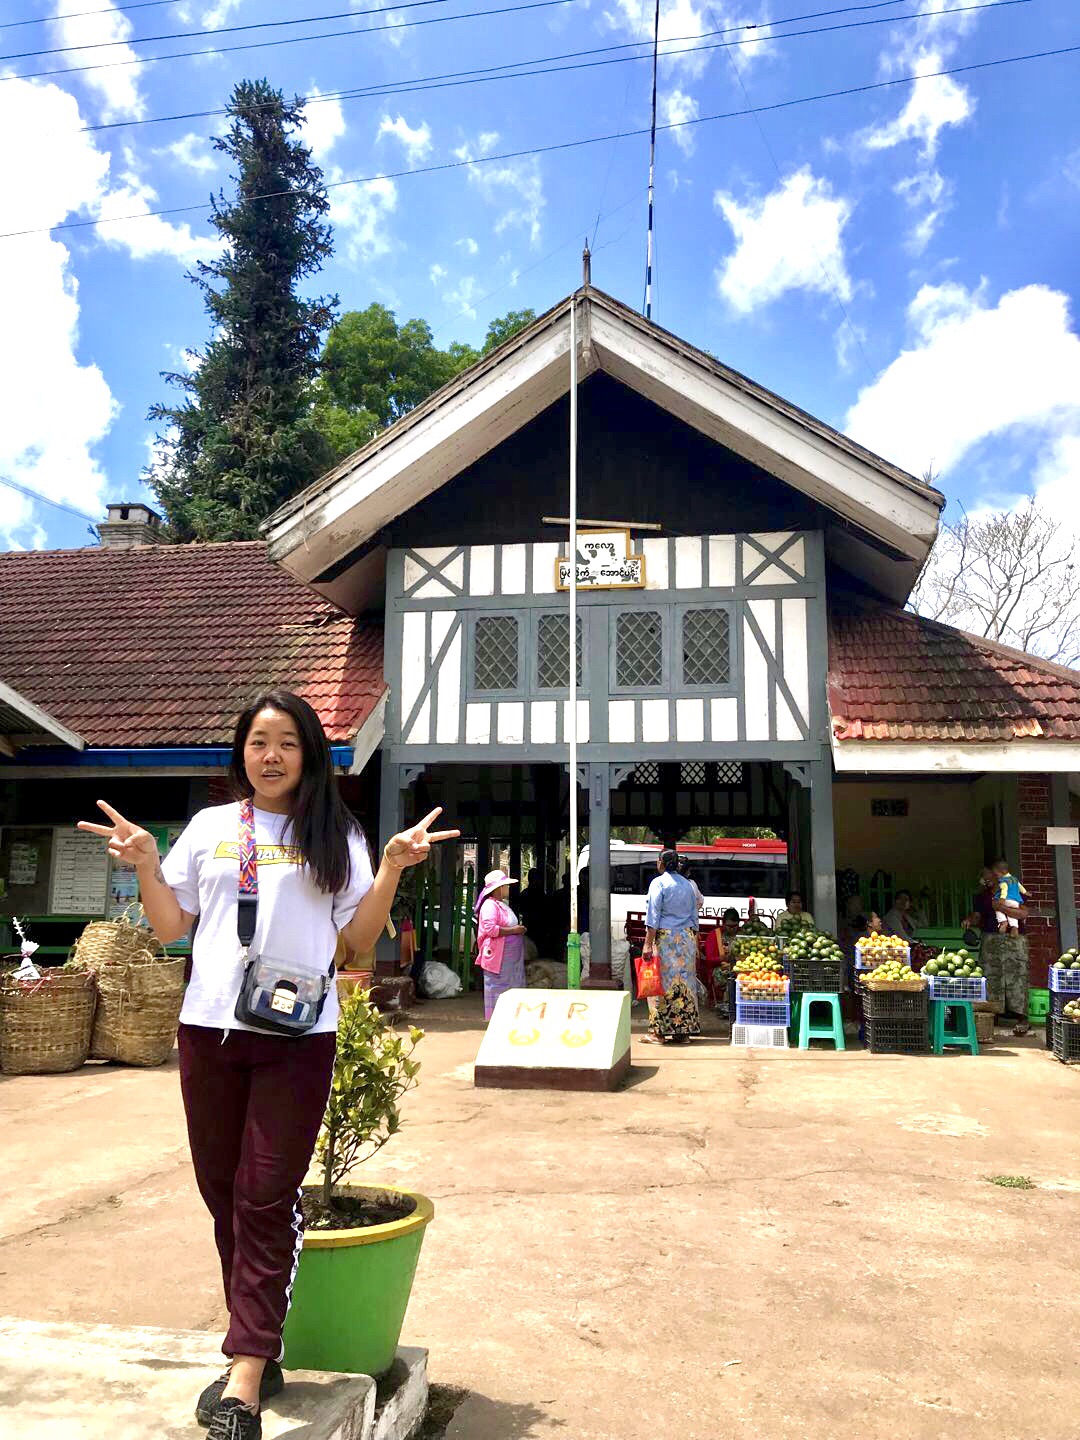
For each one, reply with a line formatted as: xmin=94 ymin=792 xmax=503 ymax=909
xmin=284 ymin=989 xmax=435 ymax=1375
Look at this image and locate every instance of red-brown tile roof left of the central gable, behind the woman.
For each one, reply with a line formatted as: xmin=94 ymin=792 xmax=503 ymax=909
xmin=0 ymin=541 xmax=384 ymax=747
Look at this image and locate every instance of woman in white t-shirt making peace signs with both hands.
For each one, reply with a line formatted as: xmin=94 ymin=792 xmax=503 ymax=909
xmin=79 ymin=690 xmax=458 ymax=1440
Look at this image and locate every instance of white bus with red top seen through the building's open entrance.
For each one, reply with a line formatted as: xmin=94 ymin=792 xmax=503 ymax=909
xmin=577 ymin=840 xmax=788 ymax=940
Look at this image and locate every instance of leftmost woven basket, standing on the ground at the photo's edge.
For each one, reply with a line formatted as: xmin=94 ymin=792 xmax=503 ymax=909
xmin=0 ymin=969 xmax=98 ymax=1076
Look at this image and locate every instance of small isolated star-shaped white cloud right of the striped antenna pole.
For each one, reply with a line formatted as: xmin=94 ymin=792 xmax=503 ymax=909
xmin=714 ymin=167 xmax=851 ymax=314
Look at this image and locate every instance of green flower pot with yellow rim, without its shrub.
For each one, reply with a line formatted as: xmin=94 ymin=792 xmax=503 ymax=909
xmin=284 ymin=1185 xmax=435 ymax=1375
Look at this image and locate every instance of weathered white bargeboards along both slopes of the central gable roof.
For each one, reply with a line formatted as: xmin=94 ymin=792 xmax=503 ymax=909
xmin=264 ymin=288 xmax=945 ymax=600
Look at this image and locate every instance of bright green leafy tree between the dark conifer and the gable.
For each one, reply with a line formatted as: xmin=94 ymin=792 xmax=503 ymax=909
xmin=315 ymin=302 xmax=536 ymax=459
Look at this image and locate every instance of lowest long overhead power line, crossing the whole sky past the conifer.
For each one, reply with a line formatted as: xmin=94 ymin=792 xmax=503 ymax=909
xmin=0 ymin=43 xmax=1080 ymax=240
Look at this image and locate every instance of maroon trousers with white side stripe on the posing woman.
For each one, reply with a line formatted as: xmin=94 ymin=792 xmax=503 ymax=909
xmin=179 ymin=1025 xmax=337 ymax=1359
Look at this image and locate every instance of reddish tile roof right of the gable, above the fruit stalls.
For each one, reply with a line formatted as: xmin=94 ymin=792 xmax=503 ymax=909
xmin=828 ymin=593 xmax=1080 ymax=742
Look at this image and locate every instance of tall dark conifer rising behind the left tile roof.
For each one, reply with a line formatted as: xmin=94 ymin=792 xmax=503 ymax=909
xmin=147 ymin=81 xmax=337 ymax=540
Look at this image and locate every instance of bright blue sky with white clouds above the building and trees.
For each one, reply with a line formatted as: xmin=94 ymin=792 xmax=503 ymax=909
xmin=0 ymin=0 xmax=1080 ymax=547
